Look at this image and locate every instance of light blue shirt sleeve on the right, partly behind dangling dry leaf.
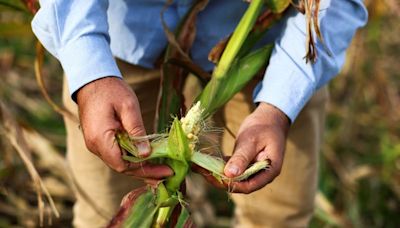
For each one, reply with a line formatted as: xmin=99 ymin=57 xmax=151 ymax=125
xmin=254 ymin=0 xmax=368 ymax=122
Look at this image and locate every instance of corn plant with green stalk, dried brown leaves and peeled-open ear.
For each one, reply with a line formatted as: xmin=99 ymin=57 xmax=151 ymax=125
xmin=0 ymin=0 xmax=322 ymax=227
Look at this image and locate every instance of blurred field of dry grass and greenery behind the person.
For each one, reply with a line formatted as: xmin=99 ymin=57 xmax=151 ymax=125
xmin=0 ymin=0 xmax=400 ymax=227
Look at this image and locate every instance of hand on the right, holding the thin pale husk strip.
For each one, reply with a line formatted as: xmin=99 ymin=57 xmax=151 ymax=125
xmin=224 ymin=102 xmax=290 ymax=194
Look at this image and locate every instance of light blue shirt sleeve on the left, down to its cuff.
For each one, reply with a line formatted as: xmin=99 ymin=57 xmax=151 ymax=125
xmin=32 ymin=0 xmax=121 ymax=98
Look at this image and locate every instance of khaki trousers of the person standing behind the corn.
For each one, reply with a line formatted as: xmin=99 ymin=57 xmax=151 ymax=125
xmin=64 ymin=59 xmax=327 ymax=228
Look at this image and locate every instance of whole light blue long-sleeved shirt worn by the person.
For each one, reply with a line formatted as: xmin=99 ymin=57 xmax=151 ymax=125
xmin=32 ymin=0 xmax=367 ymax=122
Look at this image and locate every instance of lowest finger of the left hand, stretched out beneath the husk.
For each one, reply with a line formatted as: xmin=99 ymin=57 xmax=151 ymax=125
xmin=123 ymin=164 xmax=174 ymax=179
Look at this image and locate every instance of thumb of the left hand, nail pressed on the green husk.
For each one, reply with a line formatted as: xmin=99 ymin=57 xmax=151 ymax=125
xmin=117 ymin=95 xmax=151 ymax=157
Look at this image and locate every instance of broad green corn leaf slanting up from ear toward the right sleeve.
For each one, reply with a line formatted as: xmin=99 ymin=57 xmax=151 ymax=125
xmin=198 ymin=45 xmax=272 ymax=118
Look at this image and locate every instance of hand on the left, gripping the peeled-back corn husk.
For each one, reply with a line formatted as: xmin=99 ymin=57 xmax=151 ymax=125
xmin=77 ymin=77 xmax=173 ymax=179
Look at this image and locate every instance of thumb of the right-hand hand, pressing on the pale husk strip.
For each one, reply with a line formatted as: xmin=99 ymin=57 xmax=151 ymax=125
xmin=224 ymin=132 xmax=257 ymax=178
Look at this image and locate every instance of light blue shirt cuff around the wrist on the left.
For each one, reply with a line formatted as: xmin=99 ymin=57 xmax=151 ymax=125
xmin=58 ymin=35 xmax=122 ymax=100
